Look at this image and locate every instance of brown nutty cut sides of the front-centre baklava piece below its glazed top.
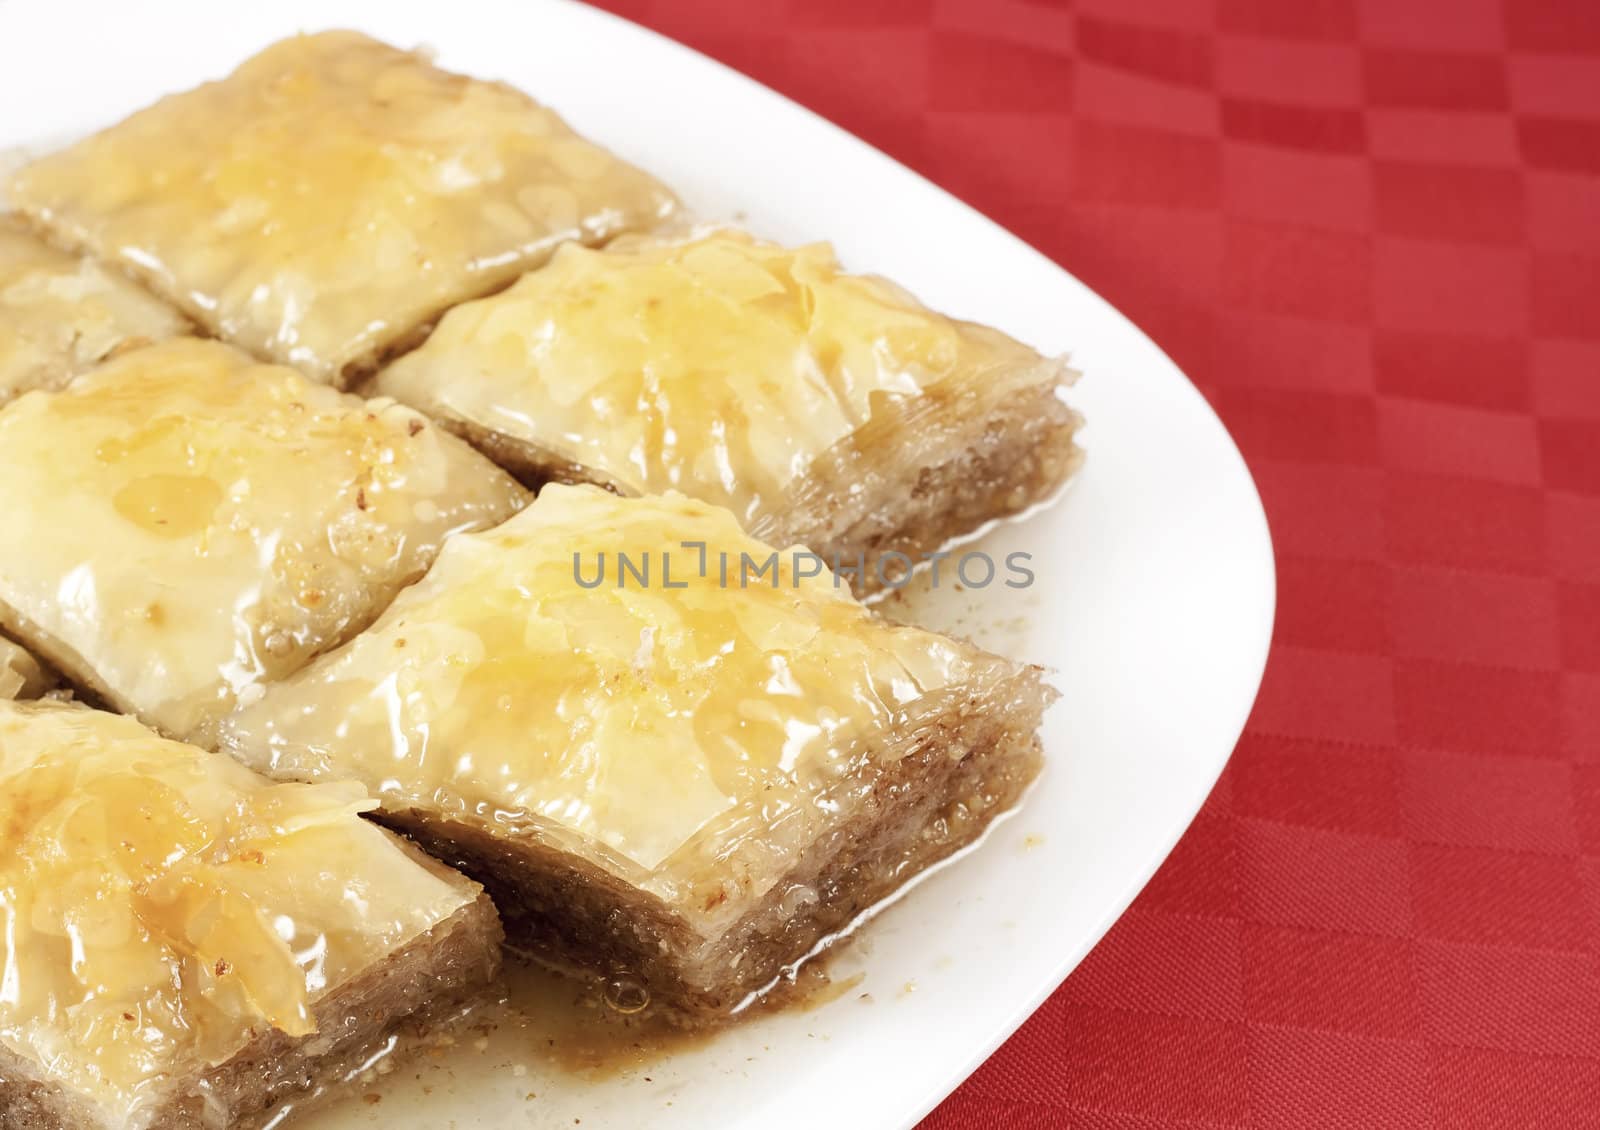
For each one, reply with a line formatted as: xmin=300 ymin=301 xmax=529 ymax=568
xmin=378 ymin=667 xmax=1054 ymax=1026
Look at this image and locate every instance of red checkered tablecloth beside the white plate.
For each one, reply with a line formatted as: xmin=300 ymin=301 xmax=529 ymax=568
xmin=592 ymin=0 xmax=1600 ymax=1130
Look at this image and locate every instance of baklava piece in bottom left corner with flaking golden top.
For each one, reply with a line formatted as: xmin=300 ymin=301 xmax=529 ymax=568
xmin=0 ymin=703 xmax=501 ymax=1130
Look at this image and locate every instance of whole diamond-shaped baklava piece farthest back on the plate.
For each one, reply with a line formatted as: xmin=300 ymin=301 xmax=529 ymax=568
xmin=11 ymin=32 xmax=674 ymax=384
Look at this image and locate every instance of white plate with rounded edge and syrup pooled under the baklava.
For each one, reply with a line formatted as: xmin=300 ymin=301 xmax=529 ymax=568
xmin=0 ymin=0 xmax=1274 ymax=1130
